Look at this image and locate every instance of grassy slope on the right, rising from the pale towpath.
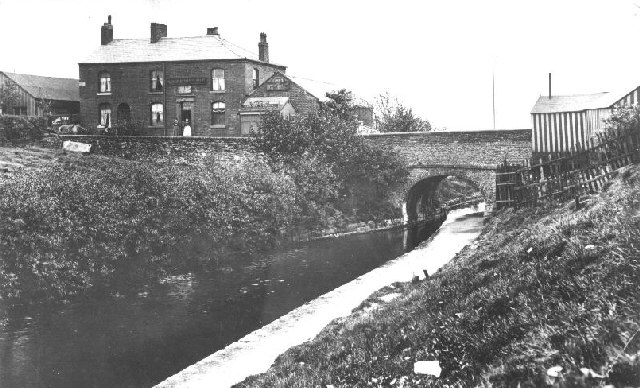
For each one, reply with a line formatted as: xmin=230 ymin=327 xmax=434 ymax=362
xmin=238 ymin=166 xmax=640 ymax=387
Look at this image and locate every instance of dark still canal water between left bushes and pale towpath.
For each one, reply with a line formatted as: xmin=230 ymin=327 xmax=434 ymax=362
xmin=0 ymin=205 xmax=482 ymax=388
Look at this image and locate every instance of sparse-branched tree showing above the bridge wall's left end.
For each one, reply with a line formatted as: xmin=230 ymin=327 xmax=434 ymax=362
xmin=375 ymin=92 xmax=431 ymax=132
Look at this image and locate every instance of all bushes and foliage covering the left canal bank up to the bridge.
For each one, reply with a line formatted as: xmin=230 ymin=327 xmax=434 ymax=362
xmin=0 ymin=113 xmax=407 ymax=302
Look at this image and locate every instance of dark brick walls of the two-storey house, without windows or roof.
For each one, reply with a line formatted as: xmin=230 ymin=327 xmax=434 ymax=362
xmin=79 ymin=60 xmax=284 ymax=136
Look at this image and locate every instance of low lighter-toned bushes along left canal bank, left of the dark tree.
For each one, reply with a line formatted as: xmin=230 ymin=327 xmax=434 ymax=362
xmin=0 ymin=158 xmax=297 ymax=300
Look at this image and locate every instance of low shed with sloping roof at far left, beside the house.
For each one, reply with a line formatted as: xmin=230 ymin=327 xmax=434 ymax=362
xmin=0 ymin=71 xmax=80 ymax=117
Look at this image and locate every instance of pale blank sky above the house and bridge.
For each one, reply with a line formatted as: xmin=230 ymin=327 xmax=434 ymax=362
xmin=0 ymin=0 xmax=640 ymax=130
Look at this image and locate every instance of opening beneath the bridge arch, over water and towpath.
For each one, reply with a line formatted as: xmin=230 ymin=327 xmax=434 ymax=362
xmin=404 ymin=174 xmax=487 ymax=222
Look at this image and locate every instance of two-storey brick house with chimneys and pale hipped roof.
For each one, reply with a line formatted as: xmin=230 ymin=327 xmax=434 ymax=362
xmin=78 ymin=16 xmax=286 ymax=136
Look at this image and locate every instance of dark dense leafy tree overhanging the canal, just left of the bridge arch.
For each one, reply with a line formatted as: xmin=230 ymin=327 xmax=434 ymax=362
xmin=251 ymin=109 xmax=408 ymax=220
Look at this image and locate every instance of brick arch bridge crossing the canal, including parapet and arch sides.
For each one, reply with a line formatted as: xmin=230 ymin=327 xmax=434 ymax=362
xmin=366 ymin=129 xmax=531 ymax=221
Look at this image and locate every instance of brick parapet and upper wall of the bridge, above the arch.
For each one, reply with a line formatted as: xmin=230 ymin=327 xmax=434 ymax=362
xmin=366 ymin=129 xmax=531 ymax=166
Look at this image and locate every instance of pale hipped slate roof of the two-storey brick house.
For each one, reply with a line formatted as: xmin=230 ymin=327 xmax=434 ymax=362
xmin=80 ymin=35 xmax=284 ymax=67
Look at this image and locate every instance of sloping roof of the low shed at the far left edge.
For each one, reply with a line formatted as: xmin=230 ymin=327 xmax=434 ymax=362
xmin=3 ymin=72 xmax=80 ymax=101
